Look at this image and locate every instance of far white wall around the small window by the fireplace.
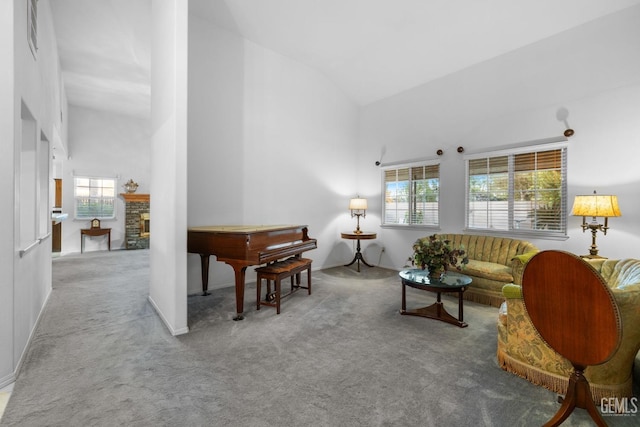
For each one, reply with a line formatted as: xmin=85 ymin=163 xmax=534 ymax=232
xmin=61 ymin=106 xmax=153 ymax=254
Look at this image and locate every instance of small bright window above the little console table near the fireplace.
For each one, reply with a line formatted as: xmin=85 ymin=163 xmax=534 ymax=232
xmin=73 ymin=176 xmax=116 ymax=219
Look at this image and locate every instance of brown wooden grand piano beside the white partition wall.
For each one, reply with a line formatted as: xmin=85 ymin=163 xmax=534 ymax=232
xmin=187 ymin=225 xmax=318 ymax=320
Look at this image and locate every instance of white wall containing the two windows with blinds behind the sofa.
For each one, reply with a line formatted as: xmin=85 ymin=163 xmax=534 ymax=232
xmin=359 ymin=7 xmax=640 ymax=268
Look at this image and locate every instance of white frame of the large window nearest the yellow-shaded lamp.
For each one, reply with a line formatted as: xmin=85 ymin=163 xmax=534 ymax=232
xmin=464 ymin=139 xmax=568 ymax=240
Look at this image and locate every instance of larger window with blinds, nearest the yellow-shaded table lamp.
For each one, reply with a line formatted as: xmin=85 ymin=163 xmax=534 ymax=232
xmin=466 ymin=144 xmax=567 ymax=236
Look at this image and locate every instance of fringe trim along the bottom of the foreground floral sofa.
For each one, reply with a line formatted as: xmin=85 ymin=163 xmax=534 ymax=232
xmin=497 ymin=348 xmax=633 ymax=405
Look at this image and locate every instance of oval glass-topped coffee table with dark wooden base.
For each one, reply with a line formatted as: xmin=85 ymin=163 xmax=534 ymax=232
xmin=399 ymin=268 xmax=471 ymax=328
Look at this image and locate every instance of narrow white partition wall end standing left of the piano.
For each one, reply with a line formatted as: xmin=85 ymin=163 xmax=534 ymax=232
xmin=149 ymin=0 xmax=189 ymax=335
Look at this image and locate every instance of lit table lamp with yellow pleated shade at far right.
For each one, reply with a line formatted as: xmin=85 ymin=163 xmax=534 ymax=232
xmin=571 ymin=191 xmax=621 ymax=258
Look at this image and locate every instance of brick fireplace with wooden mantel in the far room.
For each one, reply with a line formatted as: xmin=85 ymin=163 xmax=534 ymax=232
xmin=120 ymin=193 xmax=151 ymax=249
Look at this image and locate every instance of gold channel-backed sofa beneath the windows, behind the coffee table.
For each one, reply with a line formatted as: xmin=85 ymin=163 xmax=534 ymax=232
xmin=438 ymin=234 xmax=539 ymax=307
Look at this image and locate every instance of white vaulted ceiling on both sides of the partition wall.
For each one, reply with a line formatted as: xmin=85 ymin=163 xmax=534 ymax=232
xmin=50 ymin=0 xmax=640 ymax=117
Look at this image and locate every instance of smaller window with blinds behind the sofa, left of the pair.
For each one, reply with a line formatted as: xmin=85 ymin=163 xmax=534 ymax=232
xmin=382 ymin=164 xmax=440 ymax=226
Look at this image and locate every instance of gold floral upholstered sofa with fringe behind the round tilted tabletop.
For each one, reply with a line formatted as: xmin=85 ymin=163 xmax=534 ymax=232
xmin=497 ymin=259 xmax=640 ymax=402
